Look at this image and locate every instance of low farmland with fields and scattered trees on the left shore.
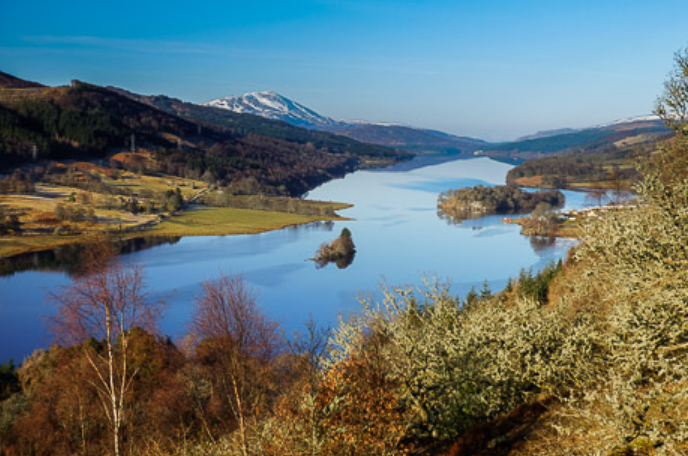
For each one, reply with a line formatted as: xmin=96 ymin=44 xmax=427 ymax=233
xmin=0 ymin=162 xmax=348 ymax=258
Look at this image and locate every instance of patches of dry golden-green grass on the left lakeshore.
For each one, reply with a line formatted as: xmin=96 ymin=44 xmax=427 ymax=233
xmin=0 ymin=163 xmax=350 ymax=257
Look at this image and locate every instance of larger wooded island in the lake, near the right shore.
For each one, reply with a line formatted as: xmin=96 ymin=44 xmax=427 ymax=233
xmin=437 ymin=185 xmax=564 ymax=222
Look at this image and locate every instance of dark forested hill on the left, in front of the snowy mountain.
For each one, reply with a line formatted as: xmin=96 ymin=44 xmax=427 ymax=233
xmin=0 ymin=71 xmax=404 ymax=195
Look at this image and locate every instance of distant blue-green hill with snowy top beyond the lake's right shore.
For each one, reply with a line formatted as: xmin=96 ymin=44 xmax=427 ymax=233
xmin=482 ymin=116 xmax=671 ymax=161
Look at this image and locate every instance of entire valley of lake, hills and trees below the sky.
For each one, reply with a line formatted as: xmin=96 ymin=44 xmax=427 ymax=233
xmin=0 ymin=50 xmax=687 ymax=456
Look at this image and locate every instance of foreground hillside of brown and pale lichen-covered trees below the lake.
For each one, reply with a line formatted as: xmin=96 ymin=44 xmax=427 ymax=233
xmin=0 ymin=50 xmax=688 ymax=456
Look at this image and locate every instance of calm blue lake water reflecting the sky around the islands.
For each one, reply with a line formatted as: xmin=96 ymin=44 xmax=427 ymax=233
xmin=0 ymin=158 xmax=585 ymax=361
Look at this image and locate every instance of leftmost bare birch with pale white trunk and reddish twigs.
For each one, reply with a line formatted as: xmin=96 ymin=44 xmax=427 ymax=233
xmin=51 ymin=244 xmax=162 ymax=456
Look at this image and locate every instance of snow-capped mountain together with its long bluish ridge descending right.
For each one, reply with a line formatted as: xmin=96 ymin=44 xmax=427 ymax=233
xmin=203 ymin=92 xmax=489 ymax=155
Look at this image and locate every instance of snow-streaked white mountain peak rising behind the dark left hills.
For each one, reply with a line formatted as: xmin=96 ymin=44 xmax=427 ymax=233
xmin=203 ymin=92 xmax=339 ymax=128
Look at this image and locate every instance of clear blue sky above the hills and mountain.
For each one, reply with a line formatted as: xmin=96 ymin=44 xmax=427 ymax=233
xmin=0 ymin=0 xmax=688 ymax=140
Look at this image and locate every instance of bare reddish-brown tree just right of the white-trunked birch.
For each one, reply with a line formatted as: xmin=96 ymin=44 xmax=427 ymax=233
xmin=191 ymin=275 xmax=280 ymax=456
